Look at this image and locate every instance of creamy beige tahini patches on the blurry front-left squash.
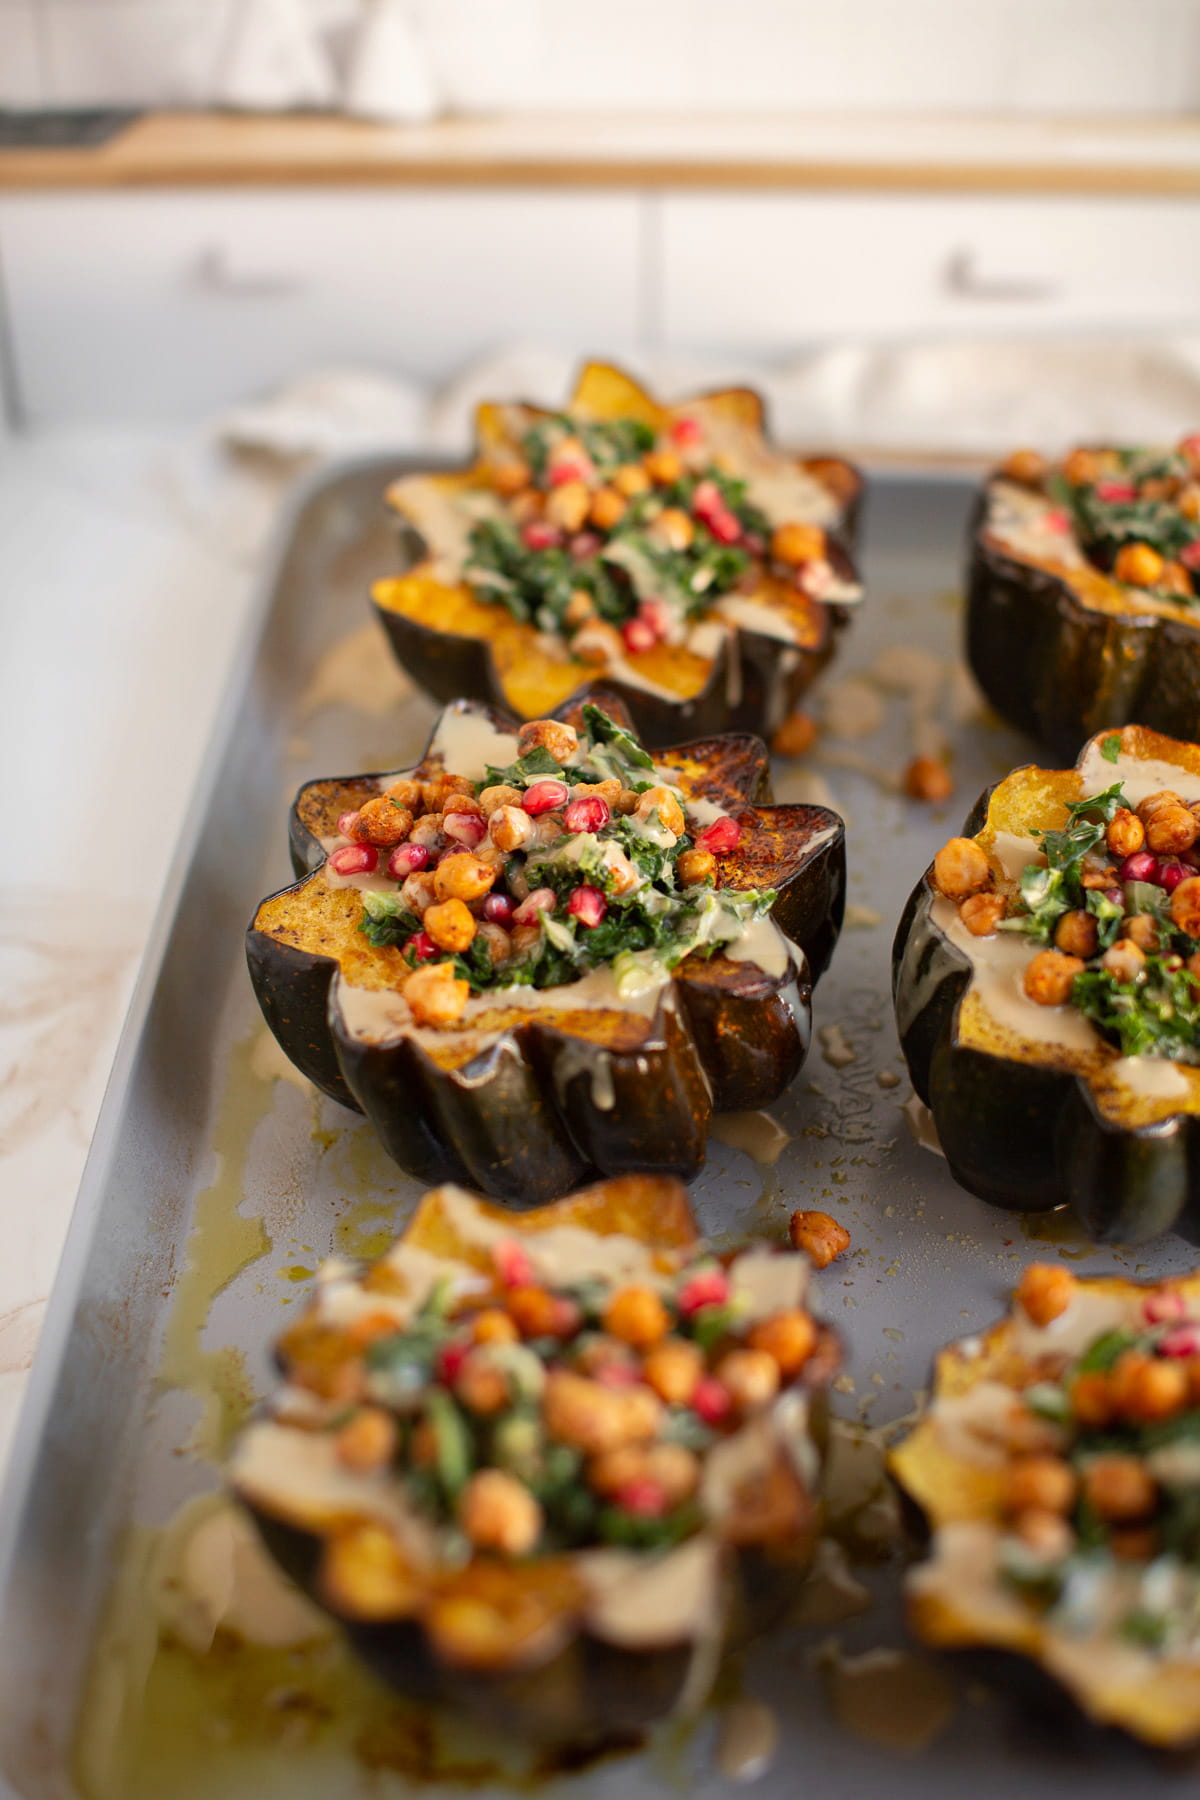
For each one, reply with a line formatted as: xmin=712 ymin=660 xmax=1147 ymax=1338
xmin=228 ymin=1186 xmax=817 ymax=1647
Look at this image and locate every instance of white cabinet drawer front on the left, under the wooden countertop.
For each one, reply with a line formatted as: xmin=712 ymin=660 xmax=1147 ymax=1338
xmin=0 ymin=187 xmax=640 ymax=425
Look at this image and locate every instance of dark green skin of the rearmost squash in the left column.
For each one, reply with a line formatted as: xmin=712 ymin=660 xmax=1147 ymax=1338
xmin=372 ymin=504 xmax=862 ymax=751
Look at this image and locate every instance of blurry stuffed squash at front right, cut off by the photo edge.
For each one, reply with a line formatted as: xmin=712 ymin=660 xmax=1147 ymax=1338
xmin=891 ymin=1264 xmax=1200 ymax=1748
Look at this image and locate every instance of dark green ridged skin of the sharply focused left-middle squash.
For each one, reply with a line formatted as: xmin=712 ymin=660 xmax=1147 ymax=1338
xmin=246 ymin=695 xmax=846 ymax=1206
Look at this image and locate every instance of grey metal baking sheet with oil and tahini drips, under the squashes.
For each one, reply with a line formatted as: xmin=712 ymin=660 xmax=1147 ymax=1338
xmin=0 ymin=459 xmax=1193 ymax=1800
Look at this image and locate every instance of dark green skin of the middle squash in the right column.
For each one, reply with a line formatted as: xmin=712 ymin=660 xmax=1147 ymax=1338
xmin=892 ymin=781 xmax=1200 ymax=1244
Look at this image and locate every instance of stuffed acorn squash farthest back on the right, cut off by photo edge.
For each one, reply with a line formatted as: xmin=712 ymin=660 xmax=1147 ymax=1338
xmin=966 ymin=446 xmax=1200 ymax=758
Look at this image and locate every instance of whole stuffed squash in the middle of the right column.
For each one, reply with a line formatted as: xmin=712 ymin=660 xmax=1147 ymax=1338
xmin=892 ymin=725 xmax=1200 ymax=1244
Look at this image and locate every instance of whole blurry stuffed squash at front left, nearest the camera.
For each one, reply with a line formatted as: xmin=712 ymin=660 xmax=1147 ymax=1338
xmin=228 ymin=1175 xmax=838 ymax=1742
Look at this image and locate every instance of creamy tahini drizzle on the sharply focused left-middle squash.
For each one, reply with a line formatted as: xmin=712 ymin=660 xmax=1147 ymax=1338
xmin=320 ymin=711 xmax=805 ymax=1051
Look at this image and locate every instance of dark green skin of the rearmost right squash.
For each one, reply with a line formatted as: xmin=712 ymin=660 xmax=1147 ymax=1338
xmin=966 ymin=495 xmax=1200 ymax=763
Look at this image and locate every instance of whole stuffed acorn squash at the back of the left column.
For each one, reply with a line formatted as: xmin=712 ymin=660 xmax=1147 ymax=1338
xmin=374 ymin=364 xmax=862 ymax=745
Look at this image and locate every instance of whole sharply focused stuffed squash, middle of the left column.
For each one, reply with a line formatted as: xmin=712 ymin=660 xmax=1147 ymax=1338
xmin=246 ymin=700 xmax=844 ymax=1206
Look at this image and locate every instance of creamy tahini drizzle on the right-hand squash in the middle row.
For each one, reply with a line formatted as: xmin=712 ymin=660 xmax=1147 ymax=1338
xmin=930 ymin=740 xmax=1200 ymax=1100
